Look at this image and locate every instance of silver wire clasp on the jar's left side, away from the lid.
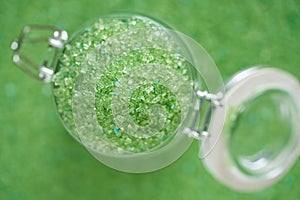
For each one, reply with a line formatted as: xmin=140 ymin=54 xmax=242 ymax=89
xmin=11 ymin=25 xmax=68 ymax=82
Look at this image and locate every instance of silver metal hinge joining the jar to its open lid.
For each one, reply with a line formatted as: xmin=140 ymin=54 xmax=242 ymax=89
xmin=183 ymin=90 xmax=223 ymax=140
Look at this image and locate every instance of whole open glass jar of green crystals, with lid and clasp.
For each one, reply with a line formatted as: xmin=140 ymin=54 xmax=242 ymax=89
xmin=12 ymin=14 xmax=300 ymax=191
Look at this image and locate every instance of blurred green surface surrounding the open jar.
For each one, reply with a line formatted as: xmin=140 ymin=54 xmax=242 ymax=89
xmin=0 ymin=0 xmax=300 ymax=200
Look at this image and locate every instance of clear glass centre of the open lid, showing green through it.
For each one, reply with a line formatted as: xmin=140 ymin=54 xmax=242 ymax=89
xmin=228 ymin=90 xmax=295 ymax=176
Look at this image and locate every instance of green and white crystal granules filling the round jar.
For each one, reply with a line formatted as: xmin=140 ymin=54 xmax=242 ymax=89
xmin=53 ymin=15 xmax=192 ymax=154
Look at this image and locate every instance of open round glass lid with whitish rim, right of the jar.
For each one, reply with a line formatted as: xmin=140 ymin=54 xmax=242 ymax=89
xmin=204 ymin=67 xmax=300 ymax=191
